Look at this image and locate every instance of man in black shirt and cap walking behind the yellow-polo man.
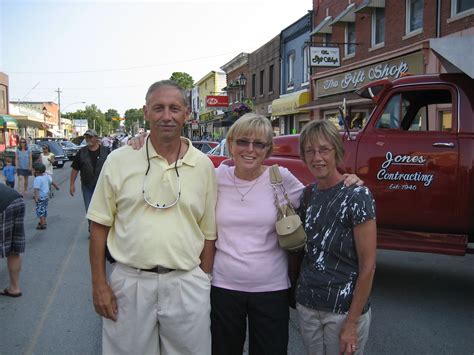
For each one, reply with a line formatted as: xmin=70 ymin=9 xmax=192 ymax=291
xmin=69 ymin=129 xmax=109 ymax=229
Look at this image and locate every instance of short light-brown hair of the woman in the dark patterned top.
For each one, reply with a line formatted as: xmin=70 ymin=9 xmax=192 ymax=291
xmin=300 ymin=120 xmax=344 ymax=164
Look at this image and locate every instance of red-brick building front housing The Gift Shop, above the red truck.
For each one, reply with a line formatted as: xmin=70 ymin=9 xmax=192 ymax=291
xmin=306 ymin=0 xmax=474 ymax=126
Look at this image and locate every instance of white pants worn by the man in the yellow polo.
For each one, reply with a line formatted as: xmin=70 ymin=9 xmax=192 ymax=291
xmin=102 ymin=263 xmax=211 ymax=355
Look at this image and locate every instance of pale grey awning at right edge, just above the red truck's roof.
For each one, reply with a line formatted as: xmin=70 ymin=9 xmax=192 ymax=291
xmin=430 ymin=36 xmax=474 ymax=79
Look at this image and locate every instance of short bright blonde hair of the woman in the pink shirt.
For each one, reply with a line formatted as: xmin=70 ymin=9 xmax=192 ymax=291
xmin=226 ymin=112 xmax=273 ymax=158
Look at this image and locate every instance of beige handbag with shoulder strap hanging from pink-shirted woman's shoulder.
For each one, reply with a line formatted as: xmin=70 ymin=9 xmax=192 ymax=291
xmin=270 ymin=164 xmax=306 ymax=251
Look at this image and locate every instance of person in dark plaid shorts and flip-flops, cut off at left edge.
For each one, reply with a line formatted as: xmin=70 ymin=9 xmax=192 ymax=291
xmin=0 ymin=184 xmax=25 ymax=297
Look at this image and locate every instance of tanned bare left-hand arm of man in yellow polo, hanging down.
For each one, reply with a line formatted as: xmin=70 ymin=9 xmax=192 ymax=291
xmin=89 ymin=222 xmax=118 ymax=321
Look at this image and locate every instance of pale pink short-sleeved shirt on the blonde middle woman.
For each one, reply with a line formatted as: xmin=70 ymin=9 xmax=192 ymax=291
xmin=212 ymin=165 xmax=304 ymax=292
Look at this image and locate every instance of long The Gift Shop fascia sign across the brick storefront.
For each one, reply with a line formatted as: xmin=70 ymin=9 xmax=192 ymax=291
xmin=316 ymin=52 xmax=423 ymax=97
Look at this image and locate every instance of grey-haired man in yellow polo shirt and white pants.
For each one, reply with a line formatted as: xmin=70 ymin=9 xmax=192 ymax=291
xmin=87 ymin=80 xmax=217 ymax=354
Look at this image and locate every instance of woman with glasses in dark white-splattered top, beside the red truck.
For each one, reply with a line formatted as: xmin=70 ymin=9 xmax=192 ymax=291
xmin=296 ymin=120 xmax=377 ymax=355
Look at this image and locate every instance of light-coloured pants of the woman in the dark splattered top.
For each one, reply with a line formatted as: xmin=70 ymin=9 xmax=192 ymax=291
xmin=296 ymin=303 xmax=372 ymax=355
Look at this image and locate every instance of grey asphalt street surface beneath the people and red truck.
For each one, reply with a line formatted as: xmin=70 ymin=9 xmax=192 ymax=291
xmin=0 ymin=163 xmax=474 ymax=355
